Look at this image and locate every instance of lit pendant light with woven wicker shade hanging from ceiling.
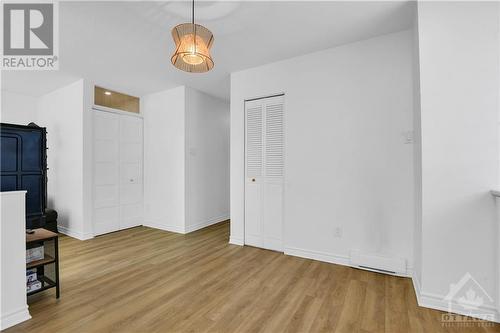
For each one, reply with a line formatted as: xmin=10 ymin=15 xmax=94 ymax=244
xmin=171 ymin=0 xmax=214 ymax=73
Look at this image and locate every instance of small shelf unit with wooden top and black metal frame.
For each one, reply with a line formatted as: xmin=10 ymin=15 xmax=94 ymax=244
xmin=26 ymin=228 xmax=60 ymax=298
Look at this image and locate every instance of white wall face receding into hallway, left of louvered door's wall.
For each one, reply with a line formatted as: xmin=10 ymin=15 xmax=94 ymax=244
xmin=185 ymin=87 xmax=229 ymax=232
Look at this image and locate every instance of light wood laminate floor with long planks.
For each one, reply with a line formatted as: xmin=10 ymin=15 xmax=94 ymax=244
xmin=7 ymin=222 xmax=500 ymax=333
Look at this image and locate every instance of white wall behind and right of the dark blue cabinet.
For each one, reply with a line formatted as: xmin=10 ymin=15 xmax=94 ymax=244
xmin=1 ymin=80 xmax=93 ymax=239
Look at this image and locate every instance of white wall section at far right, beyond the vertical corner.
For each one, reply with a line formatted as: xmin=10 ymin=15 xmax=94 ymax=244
xmin=418 ymin=2 xmax=499 ymax=316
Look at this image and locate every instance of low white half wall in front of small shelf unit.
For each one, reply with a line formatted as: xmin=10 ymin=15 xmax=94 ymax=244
xmin=0 ymin=191 xmax=31 ymax=330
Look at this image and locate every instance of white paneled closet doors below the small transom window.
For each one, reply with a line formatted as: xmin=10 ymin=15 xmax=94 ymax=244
xmin=93 ymin=110 xmax=143 ymax=235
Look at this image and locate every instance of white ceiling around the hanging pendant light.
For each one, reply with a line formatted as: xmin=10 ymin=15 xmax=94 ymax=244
xmin=2 ymin=1 xmax=414 ymax=99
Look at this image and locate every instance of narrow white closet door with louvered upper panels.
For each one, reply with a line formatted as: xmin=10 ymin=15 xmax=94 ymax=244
xmin=245 ymin=96 xmax=284 ymax=251
